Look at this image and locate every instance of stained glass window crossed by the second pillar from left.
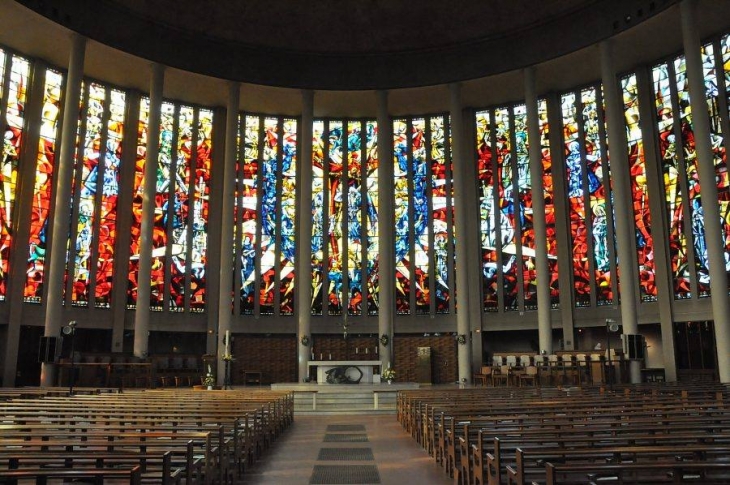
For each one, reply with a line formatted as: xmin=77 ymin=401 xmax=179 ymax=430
xmin=127 ymin=98 xmax=213 ymax=312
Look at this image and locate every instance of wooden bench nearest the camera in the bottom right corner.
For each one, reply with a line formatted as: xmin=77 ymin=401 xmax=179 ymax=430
xmin=531 ymin=461 xmax=730 ymax=485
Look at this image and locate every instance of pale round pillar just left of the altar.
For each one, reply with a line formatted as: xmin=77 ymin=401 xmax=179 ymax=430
xmin=296 ymin=89 xmax=314 ymax=382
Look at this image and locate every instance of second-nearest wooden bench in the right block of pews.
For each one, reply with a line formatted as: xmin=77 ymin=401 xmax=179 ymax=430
xmin=507 ymin=443 xmax=730 ymax=485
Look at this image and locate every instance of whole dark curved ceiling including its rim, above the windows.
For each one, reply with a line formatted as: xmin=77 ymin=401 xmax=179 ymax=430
xmin=16 ymin=0 xmax=678 ymax=90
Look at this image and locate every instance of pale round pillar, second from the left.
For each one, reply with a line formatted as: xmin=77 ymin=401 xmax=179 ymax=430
xmin=134 ymin=63 xmax=165 ymax=357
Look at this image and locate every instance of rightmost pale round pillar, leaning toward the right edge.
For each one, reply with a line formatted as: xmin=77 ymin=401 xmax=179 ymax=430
xmin=680 ymin=0 xmax=730 ymax=383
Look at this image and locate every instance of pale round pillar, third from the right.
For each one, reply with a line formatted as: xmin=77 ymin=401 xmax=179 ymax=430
xmin=525 ymin=67 xmax=553 ymax=354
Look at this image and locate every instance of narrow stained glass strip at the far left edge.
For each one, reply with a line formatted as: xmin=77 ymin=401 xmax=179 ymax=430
xmin=0 ymin=55 xmax=30 ymax=301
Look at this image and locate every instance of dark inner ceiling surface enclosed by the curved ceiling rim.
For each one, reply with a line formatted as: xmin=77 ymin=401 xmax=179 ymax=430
xmin=111 ymin=0 xmax=600 ymax=54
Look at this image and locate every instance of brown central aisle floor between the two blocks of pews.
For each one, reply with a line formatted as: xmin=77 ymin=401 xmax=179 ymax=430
xmin=243 ymin=415 xmax=453 ymax=485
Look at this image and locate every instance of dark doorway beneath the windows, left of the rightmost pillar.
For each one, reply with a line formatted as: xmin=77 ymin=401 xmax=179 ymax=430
xmin=674 ymin=321 xmax=717 ymax=381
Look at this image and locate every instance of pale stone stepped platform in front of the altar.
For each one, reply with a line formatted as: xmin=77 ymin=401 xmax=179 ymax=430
xmin=271 ymin=382 xmax=420 ymax=414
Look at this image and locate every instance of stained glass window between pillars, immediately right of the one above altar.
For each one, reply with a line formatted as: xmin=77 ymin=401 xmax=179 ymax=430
xmin=393 ymin=116 xmax=453 ymax=315
